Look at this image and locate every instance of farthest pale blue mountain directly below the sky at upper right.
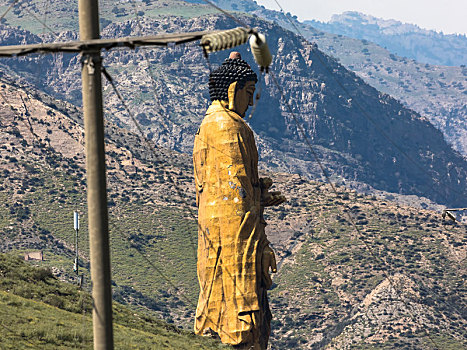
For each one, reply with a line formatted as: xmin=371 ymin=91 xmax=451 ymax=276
xmin=303 ymin=11 xmax=467 ymax=66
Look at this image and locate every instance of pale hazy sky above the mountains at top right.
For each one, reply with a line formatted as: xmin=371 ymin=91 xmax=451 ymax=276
xmin=256 ymin=0 xmax=467 ymax=34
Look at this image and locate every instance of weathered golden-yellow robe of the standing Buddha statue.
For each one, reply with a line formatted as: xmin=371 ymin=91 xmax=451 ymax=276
xmin=193 ymin=101 xmax=271 ymax=349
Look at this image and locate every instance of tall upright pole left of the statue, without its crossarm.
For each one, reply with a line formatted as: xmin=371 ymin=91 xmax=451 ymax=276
xmin=78 ymin=0 xmax=113 ymax=350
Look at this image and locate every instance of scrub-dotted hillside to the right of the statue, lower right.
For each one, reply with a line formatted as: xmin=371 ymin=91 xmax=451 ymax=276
xmin=270 ymin=177 xmax=467 ymax=350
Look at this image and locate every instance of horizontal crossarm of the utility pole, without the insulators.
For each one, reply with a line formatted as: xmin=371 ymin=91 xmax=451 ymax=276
xmin=0 ymin=30 xmax=220 ymax=57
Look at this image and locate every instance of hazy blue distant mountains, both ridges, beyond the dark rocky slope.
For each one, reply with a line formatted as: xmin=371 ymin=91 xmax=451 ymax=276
xmin=197 ymin=0 xmax=467 ymax=156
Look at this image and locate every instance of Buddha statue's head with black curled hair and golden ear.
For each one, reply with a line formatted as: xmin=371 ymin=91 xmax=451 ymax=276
xmin=209 ymin=52 xmax=258 ymax=117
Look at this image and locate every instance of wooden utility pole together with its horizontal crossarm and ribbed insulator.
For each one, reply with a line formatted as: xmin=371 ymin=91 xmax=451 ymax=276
xmin=0 ymin=5 xmax=256 ymax=350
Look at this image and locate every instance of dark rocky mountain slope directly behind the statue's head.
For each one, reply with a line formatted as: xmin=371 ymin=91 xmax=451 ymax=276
xmin=3 ymin=11 xmax=467 ymax=206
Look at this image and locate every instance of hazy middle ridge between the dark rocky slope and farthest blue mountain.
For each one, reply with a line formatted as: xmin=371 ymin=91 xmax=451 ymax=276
xmin=186 ymin=0 xmax=467 ymax=156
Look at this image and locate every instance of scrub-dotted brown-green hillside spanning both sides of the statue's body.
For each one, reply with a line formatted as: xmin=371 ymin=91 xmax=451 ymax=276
xmin=0 ymin=77 xmax=467 ymax=350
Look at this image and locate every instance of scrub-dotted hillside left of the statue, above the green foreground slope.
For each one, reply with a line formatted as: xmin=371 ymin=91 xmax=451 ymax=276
xmin=0 ymin=77 xmax=201 ymax=323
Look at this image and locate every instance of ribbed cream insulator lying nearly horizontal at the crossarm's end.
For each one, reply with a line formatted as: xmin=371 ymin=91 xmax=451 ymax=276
xmin=201 ymin=27 xmax=249 ymax=53
